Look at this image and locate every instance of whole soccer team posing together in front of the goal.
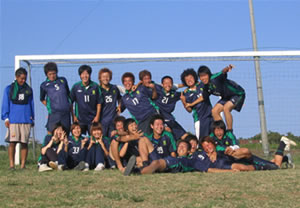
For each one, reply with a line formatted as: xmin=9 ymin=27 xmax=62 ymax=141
xmin=1 ymin=62 xmax=296 ymax=175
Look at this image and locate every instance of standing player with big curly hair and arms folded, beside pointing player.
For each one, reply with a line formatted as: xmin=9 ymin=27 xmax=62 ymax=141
xmin=180 ymin=69 xmax=212 ymax=139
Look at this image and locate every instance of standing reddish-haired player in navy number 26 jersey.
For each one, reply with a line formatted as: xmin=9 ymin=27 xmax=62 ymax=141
xmin=98 ymin=68 xmax=121 ymax=137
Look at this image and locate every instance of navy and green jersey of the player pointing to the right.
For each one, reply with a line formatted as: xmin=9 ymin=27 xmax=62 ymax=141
xmin=205 ymin=71 xmax=245 ymax=99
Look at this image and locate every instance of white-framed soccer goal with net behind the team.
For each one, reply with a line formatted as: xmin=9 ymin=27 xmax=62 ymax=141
xmin=15 ymin=51 xmax=300 ymax=164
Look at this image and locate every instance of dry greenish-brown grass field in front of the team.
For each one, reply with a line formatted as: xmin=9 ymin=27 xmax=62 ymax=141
xmin=0 ymin=147 xmax=300 ymax=207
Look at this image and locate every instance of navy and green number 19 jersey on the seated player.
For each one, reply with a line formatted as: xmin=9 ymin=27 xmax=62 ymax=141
xmin=147 ymin=131 xmax=176 ymax=158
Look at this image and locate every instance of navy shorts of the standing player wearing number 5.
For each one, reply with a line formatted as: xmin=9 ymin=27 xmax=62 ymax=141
xmin=46 ymin=112 xmax=71 ymax=133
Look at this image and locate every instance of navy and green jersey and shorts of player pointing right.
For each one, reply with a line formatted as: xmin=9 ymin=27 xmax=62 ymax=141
xmin=204 ymin=71 xmax=246 ymax=112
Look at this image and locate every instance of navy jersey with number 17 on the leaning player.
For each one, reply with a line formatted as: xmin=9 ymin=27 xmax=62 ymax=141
xmin=121 ymin=85 xmax=156 ymax=122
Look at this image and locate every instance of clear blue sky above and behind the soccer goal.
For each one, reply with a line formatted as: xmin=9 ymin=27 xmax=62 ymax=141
xmin=0 ymin=0 xmax=300 ymax=144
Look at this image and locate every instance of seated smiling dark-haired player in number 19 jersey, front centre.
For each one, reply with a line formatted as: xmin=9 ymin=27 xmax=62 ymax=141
xmin=139 ymin=115 xmax=176 ymax=167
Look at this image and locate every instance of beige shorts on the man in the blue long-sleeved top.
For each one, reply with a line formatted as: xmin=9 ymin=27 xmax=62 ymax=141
xmin=6 ymin=124 xmax=31 ymax=144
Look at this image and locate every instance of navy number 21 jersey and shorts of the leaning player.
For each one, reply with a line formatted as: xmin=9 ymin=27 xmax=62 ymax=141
xmin=154 ymin=84 xmax=186 ymax=141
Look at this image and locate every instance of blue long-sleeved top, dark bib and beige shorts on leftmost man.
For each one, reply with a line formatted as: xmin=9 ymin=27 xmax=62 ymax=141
xmin=1 ymin=81 xmax=34 ymax=144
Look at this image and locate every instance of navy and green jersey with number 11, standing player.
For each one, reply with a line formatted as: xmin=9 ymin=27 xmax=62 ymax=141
xmin=70 ymin=81 xmax=102 ymax=125
